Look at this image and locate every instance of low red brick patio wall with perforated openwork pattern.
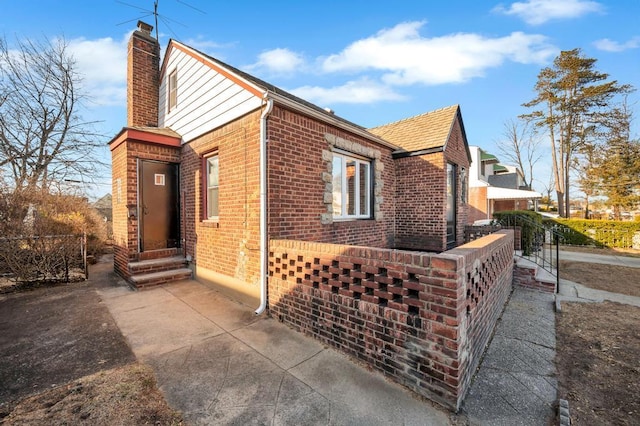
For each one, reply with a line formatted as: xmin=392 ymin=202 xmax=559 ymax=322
xmin=269 ymin=231 xmax=513 ymax=410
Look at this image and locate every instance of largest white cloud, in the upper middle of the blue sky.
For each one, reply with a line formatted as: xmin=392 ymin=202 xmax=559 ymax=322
xmin=322 ymin=22 xmax=557 ymax=85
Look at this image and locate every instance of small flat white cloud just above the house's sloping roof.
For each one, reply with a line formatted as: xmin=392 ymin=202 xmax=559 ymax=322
xmin=291 ymin=78 xmax=405 ymax=105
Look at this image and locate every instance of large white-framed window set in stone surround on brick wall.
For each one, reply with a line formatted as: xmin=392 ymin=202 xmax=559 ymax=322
xmin=332 ymin=151 xmax=372 ymax=219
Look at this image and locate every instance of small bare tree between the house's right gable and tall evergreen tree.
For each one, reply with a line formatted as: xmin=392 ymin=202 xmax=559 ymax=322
xmin=496 ymin=119 xmax=542 ymax=188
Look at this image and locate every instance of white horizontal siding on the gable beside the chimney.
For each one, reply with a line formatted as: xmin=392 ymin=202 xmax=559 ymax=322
xmin=158 ymin=44 xmax=262 ymax=143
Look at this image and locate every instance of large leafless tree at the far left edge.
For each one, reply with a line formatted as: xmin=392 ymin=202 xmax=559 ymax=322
xmin=0 ymin=38 xmax=104 ymax=191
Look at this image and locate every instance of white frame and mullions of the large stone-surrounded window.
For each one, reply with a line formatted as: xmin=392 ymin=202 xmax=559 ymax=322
xmin=333 ymin=150 xmax=373 ymax=221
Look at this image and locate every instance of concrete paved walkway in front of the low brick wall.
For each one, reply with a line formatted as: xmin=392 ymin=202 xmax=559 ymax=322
xmin=99 ymin=281 xmax=450 ymax=425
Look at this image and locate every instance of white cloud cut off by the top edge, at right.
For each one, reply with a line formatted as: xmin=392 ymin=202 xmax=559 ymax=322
xmin=493 ymin=0 xmax=603 ymax=25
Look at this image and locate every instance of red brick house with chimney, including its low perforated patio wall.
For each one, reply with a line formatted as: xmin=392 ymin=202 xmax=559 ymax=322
xmin=110 ymin=22 xmax=513 ymax=410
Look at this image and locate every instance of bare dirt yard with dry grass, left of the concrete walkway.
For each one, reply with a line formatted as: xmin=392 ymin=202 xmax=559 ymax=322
xmin=0 ymin=259 xmax=181 ymax=425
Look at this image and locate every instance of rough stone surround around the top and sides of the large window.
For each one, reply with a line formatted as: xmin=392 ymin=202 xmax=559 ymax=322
xmin=320 ymin=133 xmax=384 ymax=225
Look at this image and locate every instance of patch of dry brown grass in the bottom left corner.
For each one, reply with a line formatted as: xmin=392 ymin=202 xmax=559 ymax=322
xmin=0 ymin=364 xmax=184 ymax=426
